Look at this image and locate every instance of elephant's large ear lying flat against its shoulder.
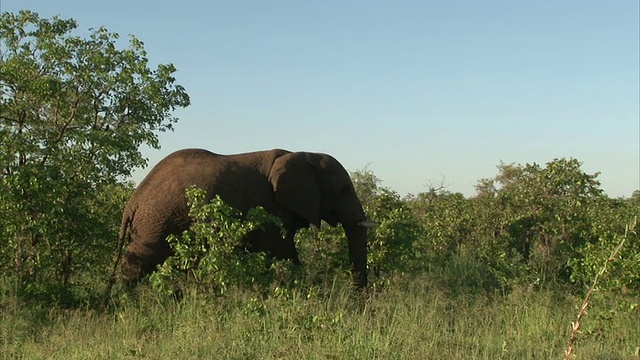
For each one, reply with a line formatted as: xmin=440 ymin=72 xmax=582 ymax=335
xmin=269 ymin=153 xmax=322 ymax=227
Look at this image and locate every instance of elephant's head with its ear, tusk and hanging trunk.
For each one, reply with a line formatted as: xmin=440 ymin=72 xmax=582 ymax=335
xmin=269 ymin=152 xmax=371 ymax=287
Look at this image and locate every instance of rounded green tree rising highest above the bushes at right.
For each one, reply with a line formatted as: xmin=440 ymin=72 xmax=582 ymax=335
xmin=477 ymin=158 xmax=606 ymax=282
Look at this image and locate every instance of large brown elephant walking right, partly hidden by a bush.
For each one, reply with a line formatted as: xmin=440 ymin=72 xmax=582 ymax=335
xmin=106 ymin=149 xmax=375 ymax=288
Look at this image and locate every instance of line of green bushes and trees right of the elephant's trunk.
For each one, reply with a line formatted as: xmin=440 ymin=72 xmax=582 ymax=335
xmin=354 ymin=158 xmax=640 ymax=295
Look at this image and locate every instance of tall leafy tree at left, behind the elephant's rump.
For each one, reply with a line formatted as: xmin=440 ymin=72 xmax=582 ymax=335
xmin=0 ymin=11 xmax=189 ymax=300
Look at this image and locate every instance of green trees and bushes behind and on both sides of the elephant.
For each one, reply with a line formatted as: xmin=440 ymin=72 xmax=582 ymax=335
xmin=0 ymin=11 xmax=640 ymax=307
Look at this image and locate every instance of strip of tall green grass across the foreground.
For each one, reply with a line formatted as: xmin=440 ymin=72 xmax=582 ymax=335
xmin=0 ymin=276 xmax=640 ymax=359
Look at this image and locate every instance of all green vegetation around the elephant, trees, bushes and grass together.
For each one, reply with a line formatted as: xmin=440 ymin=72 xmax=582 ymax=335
xmin=0 ymin=11 xmax=640 ymax=359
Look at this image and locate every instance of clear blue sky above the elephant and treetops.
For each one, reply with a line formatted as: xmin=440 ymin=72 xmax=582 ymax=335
xmin=0 ymin=0 xmax=640 ymax=197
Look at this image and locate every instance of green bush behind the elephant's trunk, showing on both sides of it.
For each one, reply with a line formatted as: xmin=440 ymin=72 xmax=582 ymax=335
xmin=296 ymin=169 xmax=421 ymax=287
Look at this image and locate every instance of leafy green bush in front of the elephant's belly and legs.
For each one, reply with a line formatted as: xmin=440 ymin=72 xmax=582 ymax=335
xmin=151 ymin=186 xmax=282 ymax=294
